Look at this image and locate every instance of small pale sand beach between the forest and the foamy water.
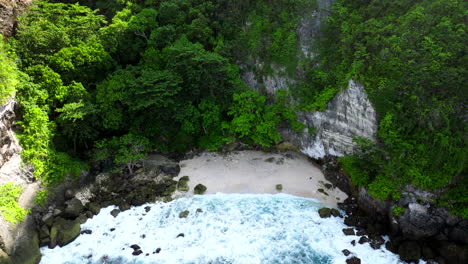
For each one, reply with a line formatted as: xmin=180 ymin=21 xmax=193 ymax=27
xmin=176 ymin=151 xmax=347 ymax=206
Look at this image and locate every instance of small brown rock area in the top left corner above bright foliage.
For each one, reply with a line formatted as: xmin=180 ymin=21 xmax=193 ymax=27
xmin=0 ymin=0 xmax=32 ymax=37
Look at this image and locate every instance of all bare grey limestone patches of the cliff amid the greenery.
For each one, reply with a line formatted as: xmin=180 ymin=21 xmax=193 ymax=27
xmin=241 ymin=0 xmax=377 ymax=159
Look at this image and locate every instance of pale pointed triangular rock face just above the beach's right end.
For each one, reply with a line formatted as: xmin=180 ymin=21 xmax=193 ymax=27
xmin=282 ymin=80 xmax=378 ymax=159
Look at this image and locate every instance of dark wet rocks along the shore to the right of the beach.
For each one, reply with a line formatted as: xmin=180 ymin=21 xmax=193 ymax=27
xmin=324 ymin=158 xmax=468 ymax=264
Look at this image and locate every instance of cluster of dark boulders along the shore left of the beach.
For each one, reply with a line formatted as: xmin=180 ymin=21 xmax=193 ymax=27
xmin=35 ymin=155 xmax=180 ymax=253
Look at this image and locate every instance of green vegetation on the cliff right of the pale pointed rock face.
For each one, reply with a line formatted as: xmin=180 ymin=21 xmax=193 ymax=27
xmin=322 ymin=0 xmax=468 ymax=217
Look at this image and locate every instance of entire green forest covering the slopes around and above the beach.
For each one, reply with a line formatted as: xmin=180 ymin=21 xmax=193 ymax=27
xmin=0 ymin=0 xmax=468 ymax=216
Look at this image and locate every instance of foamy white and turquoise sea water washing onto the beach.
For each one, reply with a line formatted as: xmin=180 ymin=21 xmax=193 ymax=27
xmin=40 ymin=193 xmax=414 ymax=264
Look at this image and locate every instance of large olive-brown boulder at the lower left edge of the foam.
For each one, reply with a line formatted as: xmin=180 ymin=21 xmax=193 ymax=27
xmin=49 ymin=217 xmax=81 ymax=248
